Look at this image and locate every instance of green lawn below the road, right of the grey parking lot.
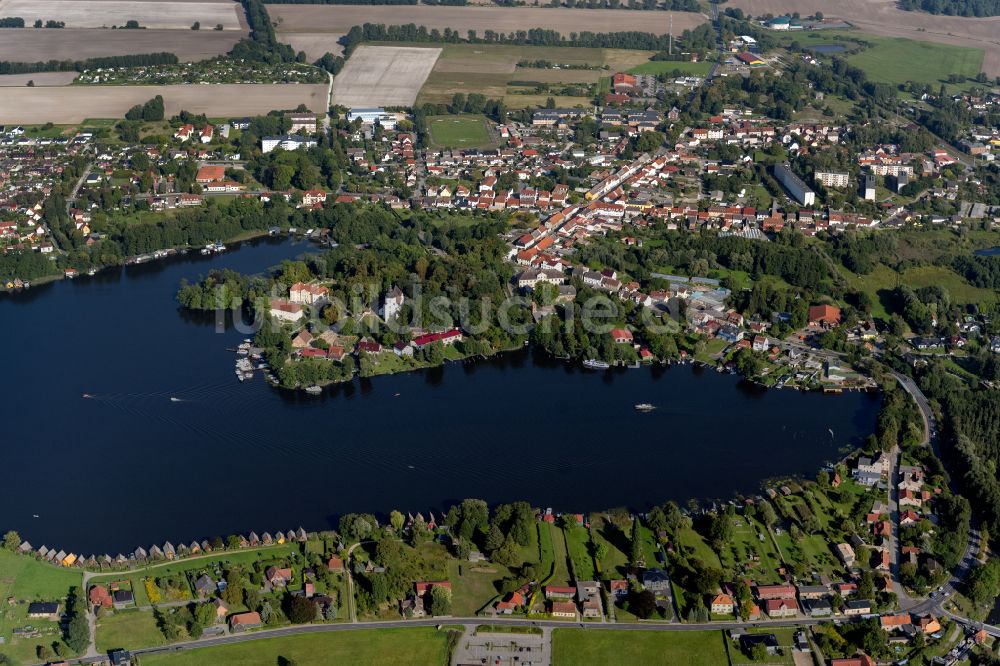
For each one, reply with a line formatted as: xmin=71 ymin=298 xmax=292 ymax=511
xmin=552 ymin=629 xmax=729 ymax=666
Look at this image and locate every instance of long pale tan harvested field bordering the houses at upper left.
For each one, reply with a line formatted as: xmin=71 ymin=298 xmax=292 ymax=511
xmin=0 ymin=84 xmax=327 ymax=123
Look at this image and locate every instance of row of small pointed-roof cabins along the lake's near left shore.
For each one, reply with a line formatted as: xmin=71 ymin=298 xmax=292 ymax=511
xmin=11 ymin=527 xmax=307 ymax=569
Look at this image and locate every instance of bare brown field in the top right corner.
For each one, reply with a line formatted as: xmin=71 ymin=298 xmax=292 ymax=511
xmin=731 ymin=0 xmax=1000 ymax=76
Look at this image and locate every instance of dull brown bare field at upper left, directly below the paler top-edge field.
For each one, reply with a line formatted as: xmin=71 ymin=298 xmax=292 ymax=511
xmin=0 ymin=28 xmax=243 ymax=62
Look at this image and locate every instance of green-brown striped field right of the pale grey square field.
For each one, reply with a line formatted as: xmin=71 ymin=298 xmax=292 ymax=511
xmin=414 ymin=44 xmax=653 ymax=108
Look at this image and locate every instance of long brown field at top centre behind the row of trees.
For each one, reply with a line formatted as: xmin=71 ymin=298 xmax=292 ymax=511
xmin=267 ymin=0 xmax=704 ymax=37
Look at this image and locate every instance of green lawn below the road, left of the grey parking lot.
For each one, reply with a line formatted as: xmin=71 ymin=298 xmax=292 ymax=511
xmin=142 ymin=627 xmax=448 ymax=666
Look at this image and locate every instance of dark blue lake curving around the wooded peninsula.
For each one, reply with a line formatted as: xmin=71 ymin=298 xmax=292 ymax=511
xmin=0 ymin=241 xmax=878 ymax=554
